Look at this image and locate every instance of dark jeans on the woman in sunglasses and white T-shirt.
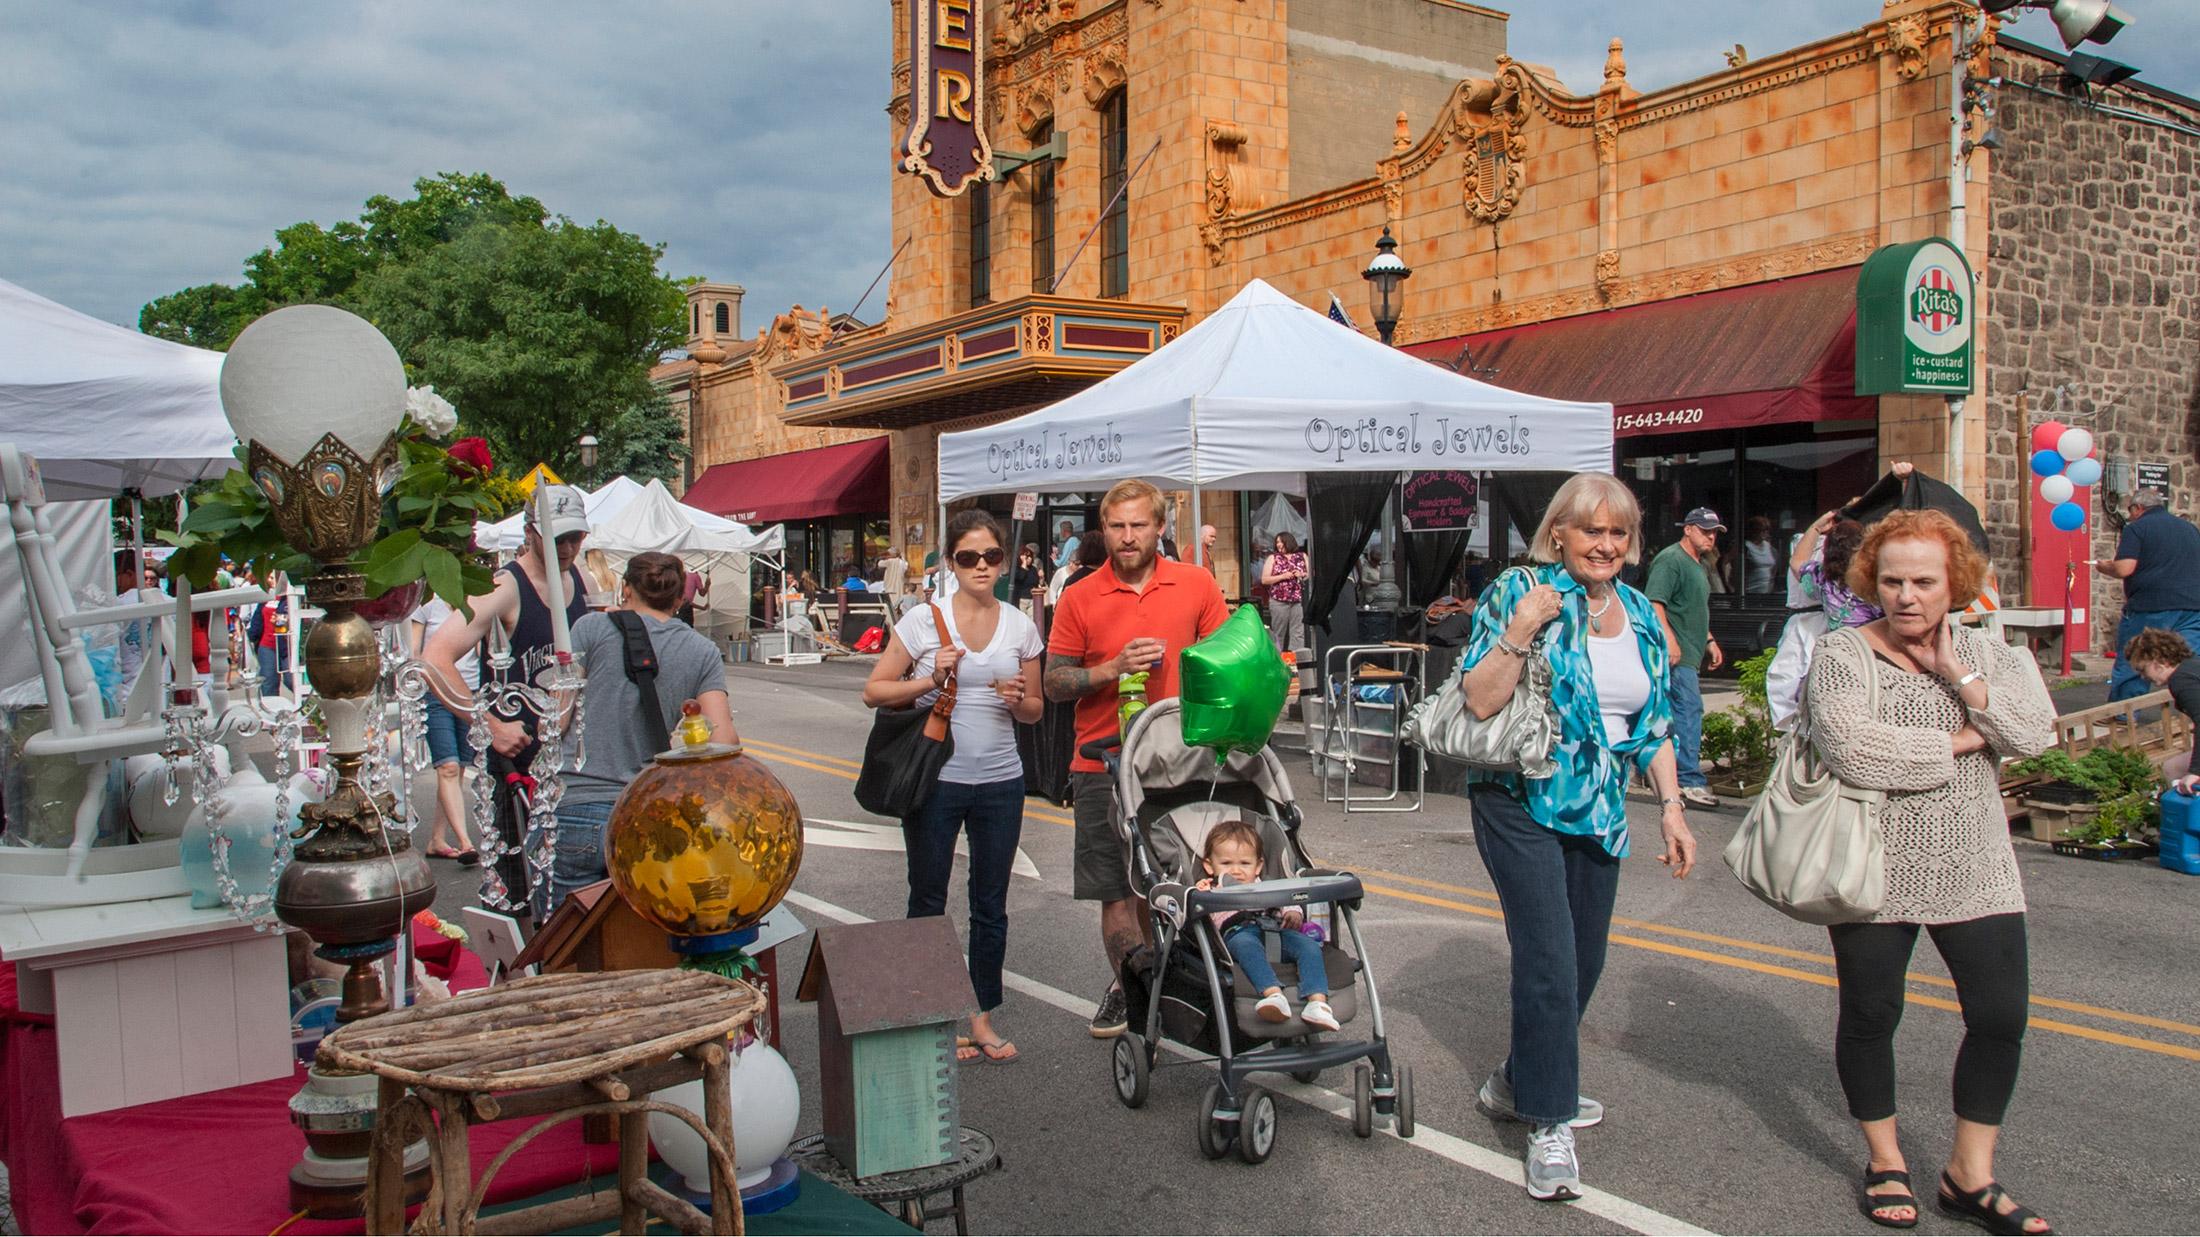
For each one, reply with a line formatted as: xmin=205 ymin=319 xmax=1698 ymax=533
xmin=902 ymin=777 xmax=1023 ymax=1010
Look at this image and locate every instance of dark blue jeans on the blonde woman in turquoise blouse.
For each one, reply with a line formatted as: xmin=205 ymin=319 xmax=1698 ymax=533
xmin=1474 ymin=786 xmax=1619 ymax=1125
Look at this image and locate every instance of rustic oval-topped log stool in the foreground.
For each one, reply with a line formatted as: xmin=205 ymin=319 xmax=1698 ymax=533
xmin=319 ymin=971 xmax=763 ymax=1235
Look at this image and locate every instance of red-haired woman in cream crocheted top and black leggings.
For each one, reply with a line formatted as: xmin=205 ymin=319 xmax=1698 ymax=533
xmin=1804 ymin=511 xmax=2055 ymax=1235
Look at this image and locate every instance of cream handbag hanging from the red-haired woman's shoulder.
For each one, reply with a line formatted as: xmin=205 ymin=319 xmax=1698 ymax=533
xmin=1723 ymin=629 xmax=1888 ymax=924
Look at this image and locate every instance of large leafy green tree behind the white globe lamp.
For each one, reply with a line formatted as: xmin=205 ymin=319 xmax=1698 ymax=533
xmin=139 ymin=172 xmax=684 ymax=473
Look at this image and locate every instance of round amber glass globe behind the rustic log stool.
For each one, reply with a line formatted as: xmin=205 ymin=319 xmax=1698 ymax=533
xmin=605 ymin=742 xmax=803 ymax=935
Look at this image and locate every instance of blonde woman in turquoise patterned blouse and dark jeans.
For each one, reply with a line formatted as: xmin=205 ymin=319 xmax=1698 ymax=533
xmin=1461 ymin=473 xmax=1696 ymax=1200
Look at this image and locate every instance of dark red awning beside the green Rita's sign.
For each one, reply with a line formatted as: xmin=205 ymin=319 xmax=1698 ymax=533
xmin=1408 ymin=266 xmax=1879 ymax=438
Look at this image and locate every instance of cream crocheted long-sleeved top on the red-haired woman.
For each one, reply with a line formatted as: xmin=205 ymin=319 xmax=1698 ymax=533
xmin=1806 ymin=627 xmax=2055 ymax=924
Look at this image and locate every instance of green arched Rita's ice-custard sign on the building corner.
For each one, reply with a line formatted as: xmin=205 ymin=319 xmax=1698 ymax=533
xmin=1857 ymin=238 xmax=1978 ymax=396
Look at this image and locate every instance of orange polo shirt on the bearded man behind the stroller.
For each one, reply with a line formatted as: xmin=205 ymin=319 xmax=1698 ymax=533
xmin=1047 ymin=557 xmax=1230 ymax=773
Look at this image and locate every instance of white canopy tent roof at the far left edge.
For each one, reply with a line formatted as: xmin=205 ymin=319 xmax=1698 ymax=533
xmin=0 ymin=280 xmax=238 ymax=502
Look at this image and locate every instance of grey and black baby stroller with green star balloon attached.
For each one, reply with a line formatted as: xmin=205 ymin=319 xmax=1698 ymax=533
xmin=1085 ymin=700 xmax=1412 ymax=1164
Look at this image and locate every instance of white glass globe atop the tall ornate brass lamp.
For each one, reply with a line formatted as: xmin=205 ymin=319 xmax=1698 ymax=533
xmin=222 ymin=306 xmax=405 ymax=464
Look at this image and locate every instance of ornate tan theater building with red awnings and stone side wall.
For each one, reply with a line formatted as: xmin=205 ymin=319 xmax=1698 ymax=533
xmin=658 ymin=0 xmax=2200 ymax=649
